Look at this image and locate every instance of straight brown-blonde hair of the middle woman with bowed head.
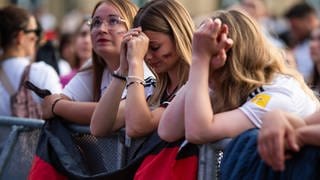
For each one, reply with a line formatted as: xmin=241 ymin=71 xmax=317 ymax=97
xmin=134 ymin=0 xmax=194 ymax=106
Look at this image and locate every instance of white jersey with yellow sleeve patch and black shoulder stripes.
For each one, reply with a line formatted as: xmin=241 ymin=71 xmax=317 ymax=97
xmin=240 ymin=75 xmax=318 ymax=128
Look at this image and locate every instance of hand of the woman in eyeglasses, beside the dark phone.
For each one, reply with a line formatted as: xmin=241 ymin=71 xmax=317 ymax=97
xmin=42 ymin=94 xmax=64 ymax=120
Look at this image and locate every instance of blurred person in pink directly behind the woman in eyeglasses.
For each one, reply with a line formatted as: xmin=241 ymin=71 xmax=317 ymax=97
xmin=60 ymin=18 xmax=92 ymax=86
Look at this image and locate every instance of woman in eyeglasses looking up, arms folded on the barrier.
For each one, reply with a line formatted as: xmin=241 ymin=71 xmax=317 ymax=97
xmin=43 ymin=0 xmax=154 ymax=124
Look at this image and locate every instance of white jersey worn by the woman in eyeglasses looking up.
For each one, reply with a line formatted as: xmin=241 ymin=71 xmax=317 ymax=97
xmin=62 ymin=61 xmax=155 ymax=102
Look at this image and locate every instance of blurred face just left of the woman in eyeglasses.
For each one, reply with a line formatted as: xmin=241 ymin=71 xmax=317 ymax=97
xmin=75 ymin=23 xmax=92 ymax=65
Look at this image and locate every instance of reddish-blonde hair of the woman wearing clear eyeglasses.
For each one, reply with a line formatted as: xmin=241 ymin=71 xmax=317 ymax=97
xmin=91 ymin=0 xmax=138 ymax=101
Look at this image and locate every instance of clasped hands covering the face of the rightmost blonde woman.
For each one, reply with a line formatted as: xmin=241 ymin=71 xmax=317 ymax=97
xmin=192 ymin=18 xmax=233 ymax=69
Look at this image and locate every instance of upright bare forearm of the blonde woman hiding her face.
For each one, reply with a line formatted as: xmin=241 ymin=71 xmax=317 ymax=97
xmin=185 ymin=60 xmax=213 ymax=143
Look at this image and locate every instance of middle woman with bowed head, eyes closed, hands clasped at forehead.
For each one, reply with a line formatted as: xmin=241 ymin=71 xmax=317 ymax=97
xmin=90 ymin=0 xmax=194 ymax=138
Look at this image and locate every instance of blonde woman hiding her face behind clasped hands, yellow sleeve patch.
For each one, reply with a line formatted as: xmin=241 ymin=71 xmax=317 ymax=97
xmin=158 ymin=10 xmax=319 ymax=144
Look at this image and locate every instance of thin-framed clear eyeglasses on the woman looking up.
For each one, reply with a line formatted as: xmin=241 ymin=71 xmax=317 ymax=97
xmin=87 ymin=15 xmax=125 ymax=30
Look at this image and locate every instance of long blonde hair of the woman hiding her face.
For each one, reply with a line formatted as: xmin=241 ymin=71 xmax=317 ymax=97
xmin=212 ymin=10 xmax=316 ymax=113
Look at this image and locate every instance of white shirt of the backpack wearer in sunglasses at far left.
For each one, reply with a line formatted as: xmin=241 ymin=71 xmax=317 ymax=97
xmin=0 ymin=57 xmax=62 ymax=116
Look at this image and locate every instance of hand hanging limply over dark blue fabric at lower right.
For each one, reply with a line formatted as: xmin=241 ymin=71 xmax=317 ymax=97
xmin=258 ymin=111 xmax=303 ymax=171
